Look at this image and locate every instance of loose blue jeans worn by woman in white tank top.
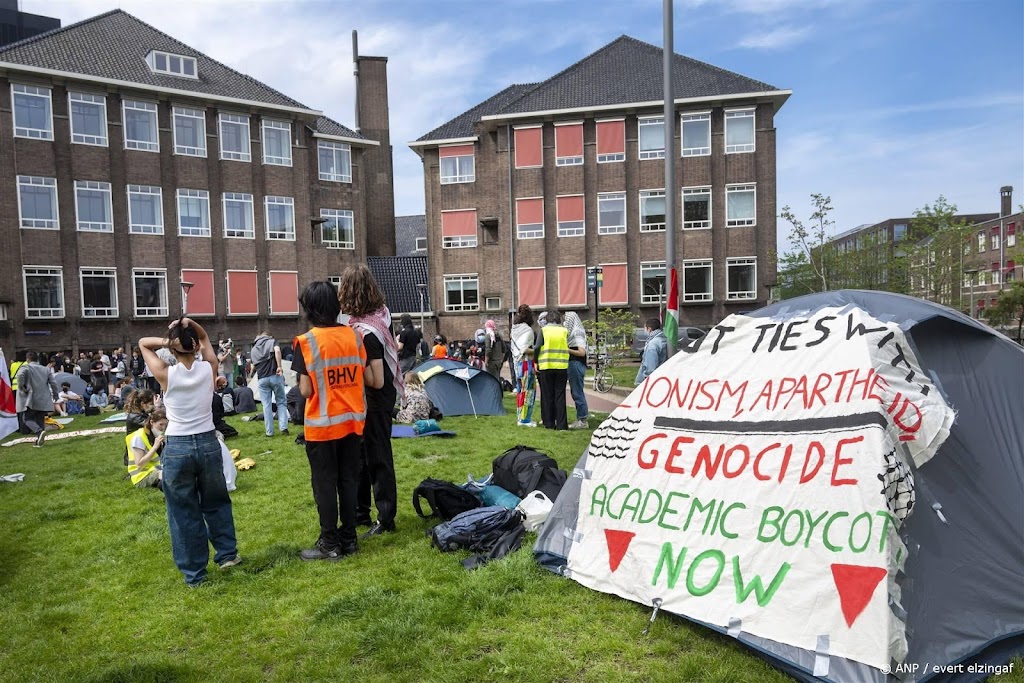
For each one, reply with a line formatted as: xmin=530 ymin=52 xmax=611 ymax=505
xmin=160 ymin=431 xmax=239 ymax=586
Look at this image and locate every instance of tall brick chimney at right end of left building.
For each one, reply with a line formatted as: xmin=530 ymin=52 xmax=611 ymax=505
xmin=352 ymin=31 xmax=395 ymax=256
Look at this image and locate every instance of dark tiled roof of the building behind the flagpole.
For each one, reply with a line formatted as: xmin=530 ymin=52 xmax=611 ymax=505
xmin=417 ymin=36 xmax=780 ymax=142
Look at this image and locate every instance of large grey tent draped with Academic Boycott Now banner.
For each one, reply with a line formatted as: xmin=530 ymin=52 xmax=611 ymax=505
xmin=535 ymin=291 xmax=1024 ymax=683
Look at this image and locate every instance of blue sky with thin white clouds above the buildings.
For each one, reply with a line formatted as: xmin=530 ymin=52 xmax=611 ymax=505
xmin=34 ymin=0 xmax=1024 ymax=250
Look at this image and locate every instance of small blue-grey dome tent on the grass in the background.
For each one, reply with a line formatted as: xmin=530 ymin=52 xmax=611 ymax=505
xmin=413 ymin=358 xmax=505 ymax=416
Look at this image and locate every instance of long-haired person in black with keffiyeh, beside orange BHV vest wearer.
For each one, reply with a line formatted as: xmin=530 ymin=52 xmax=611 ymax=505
xmin=338 ymin=263 xmax=406 ymax=539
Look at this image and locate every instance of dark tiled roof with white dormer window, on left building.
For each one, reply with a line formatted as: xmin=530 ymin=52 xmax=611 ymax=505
xmin=0 ymin=9 xmax=311 ymax=111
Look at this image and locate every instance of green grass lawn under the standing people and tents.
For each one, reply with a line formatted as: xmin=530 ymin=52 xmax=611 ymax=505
xmin=0 ymin=403 xmax=1021 ymax=683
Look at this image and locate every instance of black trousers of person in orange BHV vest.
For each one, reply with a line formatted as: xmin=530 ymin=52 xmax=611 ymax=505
xmin=306 ymin=434 xmax=362 ymax=547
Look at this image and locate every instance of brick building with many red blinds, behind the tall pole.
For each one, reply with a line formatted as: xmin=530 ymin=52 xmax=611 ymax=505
xmin=411 ymin=36 xmax=791 ymax=337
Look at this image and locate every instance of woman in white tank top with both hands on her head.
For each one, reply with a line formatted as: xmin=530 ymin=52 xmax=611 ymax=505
xmin=138 ymin=317 xmax=242 ymax=588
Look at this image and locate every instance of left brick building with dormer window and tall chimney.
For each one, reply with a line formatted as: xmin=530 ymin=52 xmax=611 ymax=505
xmin=0 ymin=10 xmax=394 ymax=356
